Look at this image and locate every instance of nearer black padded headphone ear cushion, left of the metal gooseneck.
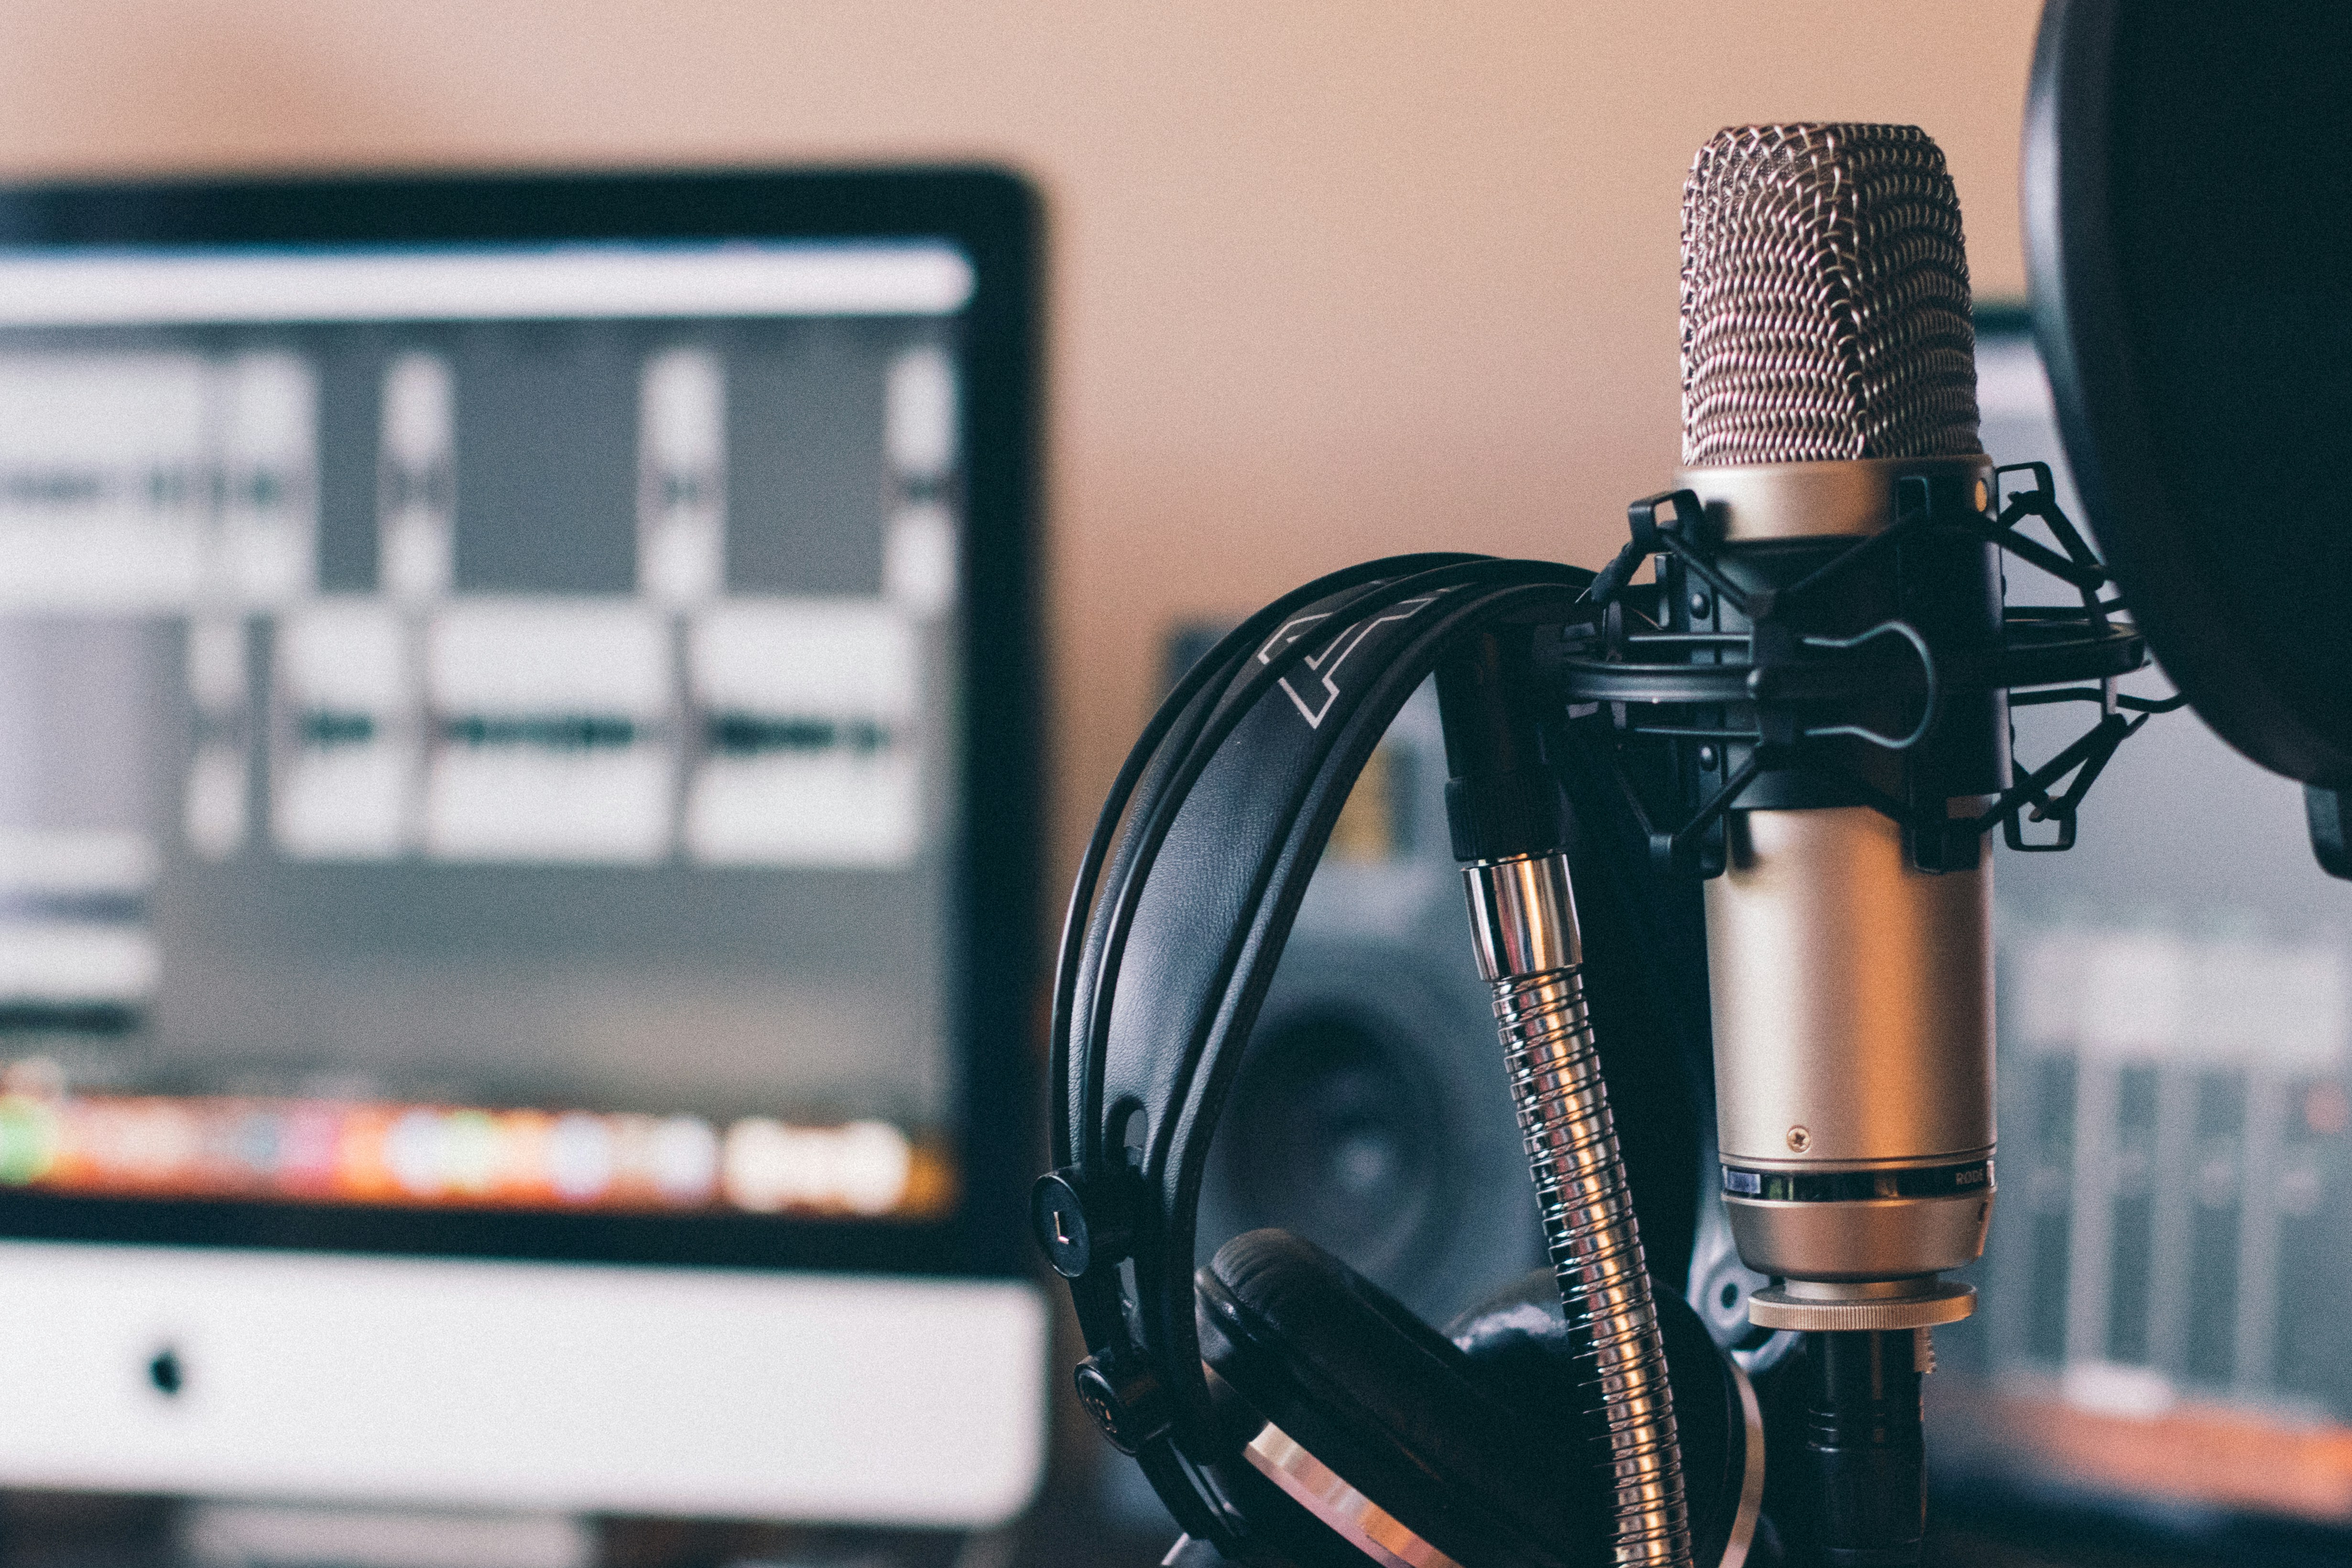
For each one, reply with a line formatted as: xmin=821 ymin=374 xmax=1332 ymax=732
xmin=1197 ymin=1230 xmax=1609 ymax=1568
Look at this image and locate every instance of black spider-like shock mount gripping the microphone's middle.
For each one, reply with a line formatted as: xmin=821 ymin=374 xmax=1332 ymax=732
xmin=1547 ymin=463 xmax=2183 ymax=877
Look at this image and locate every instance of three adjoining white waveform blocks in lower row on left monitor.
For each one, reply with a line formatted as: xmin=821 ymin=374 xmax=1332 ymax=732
xmin=269 ymin=597 xmax=922 ymax=865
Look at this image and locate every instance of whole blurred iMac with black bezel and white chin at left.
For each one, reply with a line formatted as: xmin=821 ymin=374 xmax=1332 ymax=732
xmin=0 ymin=169 xmax=1046 ymax=1525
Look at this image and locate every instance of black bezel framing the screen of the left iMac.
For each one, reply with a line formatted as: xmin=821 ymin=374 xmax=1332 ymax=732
xmin=0 ymin=164 xmax=1042 ymax=1276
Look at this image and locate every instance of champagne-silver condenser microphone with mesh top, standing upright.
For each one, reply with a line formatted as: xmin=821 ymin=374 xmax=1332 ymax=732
xmin=1677 ymin=125 xmax=2009 ymax=1563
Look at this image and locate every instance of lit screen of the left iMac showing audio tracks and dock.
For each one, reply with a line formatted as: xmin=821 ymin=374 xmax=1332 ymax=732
xmin=0 ymin=244 xmax=971 ymax=1215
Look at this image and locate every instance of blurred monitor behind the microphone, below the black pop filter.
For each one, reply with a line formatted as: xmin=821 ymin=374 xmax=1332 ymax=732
xmin=1928 ymin=313 xmax=2352 ymax=1549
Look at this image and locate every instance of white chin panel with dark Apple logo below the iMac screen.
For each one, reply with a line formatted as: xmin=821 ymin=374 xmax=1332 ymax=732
xmin=0 ymin=1241 xmax=1051 ymax=1523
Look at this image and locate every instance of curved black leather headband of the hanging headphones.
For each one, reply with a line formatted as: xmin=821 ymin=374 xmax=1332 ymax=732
xmin=1035 ymin=555 xmax=1592 ymax=1537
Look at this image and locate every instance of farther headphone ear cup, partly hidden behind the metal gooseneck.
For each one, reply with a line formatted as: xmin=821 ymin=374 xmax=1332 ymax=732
xmin=1447 ymin=1269 xmax=1780 ymax=1568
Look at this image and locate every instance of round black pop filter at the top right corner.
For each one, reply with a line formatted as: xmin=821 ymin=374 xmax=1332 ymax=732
xmin=2025 ymin=0 xmax=2352 ymax=799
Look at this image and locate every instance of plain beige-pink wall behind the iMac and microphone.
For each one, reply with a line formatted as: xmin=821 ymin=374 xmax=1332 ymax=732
xmin=0 ymin=0 xmax=2039 ymax=879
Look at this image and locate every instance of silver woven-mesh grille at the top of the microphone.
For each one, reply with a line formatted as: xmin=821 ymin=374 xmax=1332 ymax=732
xmin=1682 ymin=125 xmax=1983 ymax=468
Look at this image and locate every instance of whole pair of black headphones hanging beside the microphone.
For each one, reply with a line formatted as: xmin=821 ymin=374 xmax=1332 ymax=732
xmin=1033 ymin=555 xmax=1769 ymax=1568
